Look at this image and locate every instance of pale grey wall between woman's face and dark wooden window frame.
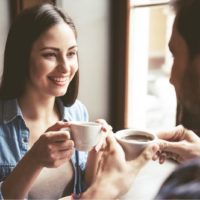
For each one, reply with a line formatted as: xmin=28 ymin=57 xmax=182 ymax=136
xmin=57 ymin=0 xmax=109 ymax=120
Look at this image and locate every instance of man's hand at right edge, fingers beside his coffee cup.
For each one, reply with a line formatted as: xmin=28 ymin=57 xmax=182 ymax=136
xmin=155 ymin=125 xmax=200 ymax=164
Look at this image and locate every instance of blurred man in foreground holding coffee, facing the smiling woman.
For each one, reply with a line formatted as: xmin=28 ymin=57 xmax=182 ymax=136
xmin=85 ymin=0 xmax=200 ymax=199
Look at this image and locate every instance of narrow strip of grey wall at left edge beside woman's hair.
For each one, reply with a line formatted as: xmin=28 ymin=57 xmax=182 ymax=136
xmin=0 ymin=0 xmax=10 ymax=76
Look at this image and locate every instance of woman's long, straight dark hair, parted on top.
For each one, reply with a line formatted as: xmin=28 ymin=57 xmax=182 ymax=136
xmin=0 ymin=3 xmax=79 ymax=106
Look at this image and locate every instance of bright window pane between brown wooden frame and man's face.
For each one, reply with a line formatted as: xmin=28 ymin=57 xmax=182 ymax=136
xmin=127 ymin=0 xmax=176 ymax=130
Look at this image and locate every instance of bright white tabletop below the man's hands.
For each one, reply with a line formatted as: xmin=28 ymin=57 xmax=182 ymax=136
xmin=120 ymin=160 xmax=177 ymax=200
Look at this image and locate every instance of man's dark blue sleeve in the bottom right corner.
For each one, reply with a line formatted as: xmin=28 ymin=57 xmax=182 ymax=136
xmin=155 ymin=158 xmax=200 ymax=199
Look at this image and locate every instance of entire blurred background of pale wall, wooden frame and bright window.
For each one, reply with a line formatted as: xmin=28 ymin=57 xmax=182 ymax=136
xmin=0 ymin=0 xmax=176 ymax=131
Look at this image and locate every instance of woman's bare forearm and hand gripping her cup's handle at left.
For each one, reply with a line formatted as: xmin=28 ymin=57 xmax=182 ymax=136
xmin=2 ymin=122 xmax=74 ymax=199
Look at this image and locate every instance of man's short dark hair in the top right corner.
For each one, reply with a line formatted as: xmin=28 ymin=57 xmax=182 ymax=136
xmin=172 ymin=0 xmax=200 ymax=57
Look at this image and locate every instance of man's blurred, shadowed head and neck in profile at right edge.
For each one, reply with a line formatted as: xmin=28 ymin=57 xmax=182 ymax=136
xmin=169 ymin=0 xmax=200 ymax=134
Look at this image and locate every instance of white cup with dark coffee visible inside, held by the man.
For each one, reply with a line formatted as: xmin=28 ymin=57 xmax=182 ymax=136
xmin=115 ymin=129 xmax=157 ymax=160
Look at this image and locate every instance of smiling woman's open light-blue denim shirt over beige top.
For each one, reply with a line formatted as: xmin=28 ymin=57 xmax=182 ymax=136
xmin=0 ymin=98 xmax=88 ymax=199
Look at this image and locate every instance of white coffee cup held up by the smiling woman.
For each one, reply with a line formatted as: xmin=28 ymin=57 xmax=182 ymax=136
xmin=69 ymin=121 xmax=102 ymax=152
